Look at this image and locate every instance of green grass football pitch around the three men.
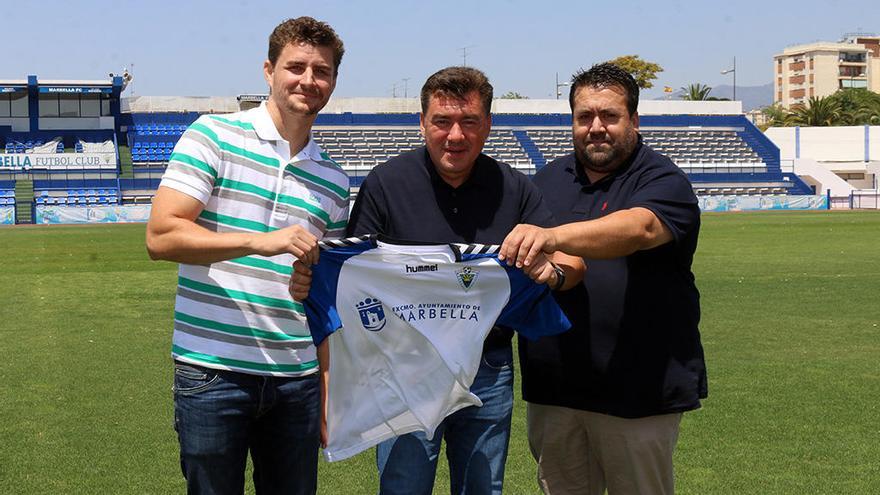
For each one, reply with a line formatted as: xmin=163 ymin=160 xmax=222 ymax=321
xmin=0 ymin=211 xmax=880 ymax=494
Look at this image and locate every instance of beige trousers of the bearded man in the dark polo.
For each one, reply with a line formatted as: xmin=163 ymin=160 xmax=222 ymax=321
xmin=528 ymin=403 xmax=681 ymax=495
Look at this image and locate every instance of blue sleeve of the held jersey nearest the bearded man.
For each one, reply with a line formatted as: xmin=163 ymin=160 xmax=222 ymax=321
xmin=488 ymin=259 xmax=571 ymax=340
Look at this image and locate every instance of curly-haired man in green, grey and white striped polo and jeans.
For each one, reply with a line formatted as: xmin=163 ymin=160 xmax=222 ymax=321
xmin=147 ymin=17 xmax=349 ymax=494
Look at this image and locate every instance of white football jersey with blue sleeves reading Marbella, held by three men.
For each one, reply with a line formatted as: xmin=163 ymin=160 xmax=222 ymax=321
xmin=305 ymin=238 xmax=570 ymax=461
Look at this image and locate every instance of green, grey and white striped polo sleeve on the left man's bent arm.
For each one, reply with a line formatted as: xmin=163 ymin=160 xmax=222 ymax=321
xmin=159 ymin=116 xmax=220 ymax=204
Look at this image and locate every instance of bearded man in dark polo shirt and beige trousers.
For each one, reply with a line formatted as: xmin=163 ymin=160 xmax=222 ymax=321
xmin=501 ymin=64 xmax=707 ymax=495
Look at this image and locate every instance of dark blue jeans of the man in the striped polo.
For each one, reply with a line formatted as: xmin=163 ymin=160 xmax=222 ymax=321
xmin=174 ymin=363 xmax=320 ymax=495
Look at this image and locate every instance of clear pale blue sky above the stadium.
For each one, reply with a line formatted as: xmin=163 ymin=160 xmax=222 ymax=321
xmin=6 ymin=0 xmax=880 ymax=98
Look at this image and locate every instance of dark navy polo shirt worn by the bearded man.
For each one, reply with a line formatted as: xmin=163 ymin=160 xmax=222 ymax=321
xmin=519 ymin=140 xmax=707 ymax=418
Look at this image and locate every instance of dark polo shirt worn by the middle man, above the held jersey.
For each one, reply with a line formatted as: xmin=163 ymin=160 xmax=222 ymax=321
xmin=346 ymin=147 xmax=553 ymax=349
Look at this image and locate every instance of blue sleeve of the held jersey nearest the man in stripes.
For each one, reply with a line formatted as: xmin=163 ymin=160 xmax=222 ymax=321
xmin=303 ymin=242 xmax=372 ymax=345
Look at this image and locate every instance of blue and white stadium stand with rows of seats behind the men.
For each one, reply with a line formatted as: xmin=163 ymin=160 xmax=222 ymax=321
xmin=0 ymin=84 xmax=821 ymax=223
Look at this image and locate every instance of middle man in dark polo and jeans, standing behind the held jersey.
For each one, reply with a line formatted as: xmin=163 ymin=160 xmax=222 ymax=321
xmin=291 ymin=67 xmax=583 ymax=495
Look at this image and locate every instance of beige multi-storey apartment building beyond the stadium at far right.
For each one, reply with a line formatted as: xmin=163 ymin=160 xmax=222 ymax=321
xmin=773 ymin=34 xmax=880 ymax=108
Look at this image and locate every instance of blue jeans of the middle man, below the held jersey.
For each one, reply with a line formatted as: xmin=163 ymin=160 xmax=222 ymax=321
xmin=376 ymin=347 xmax=513 ymax=495
